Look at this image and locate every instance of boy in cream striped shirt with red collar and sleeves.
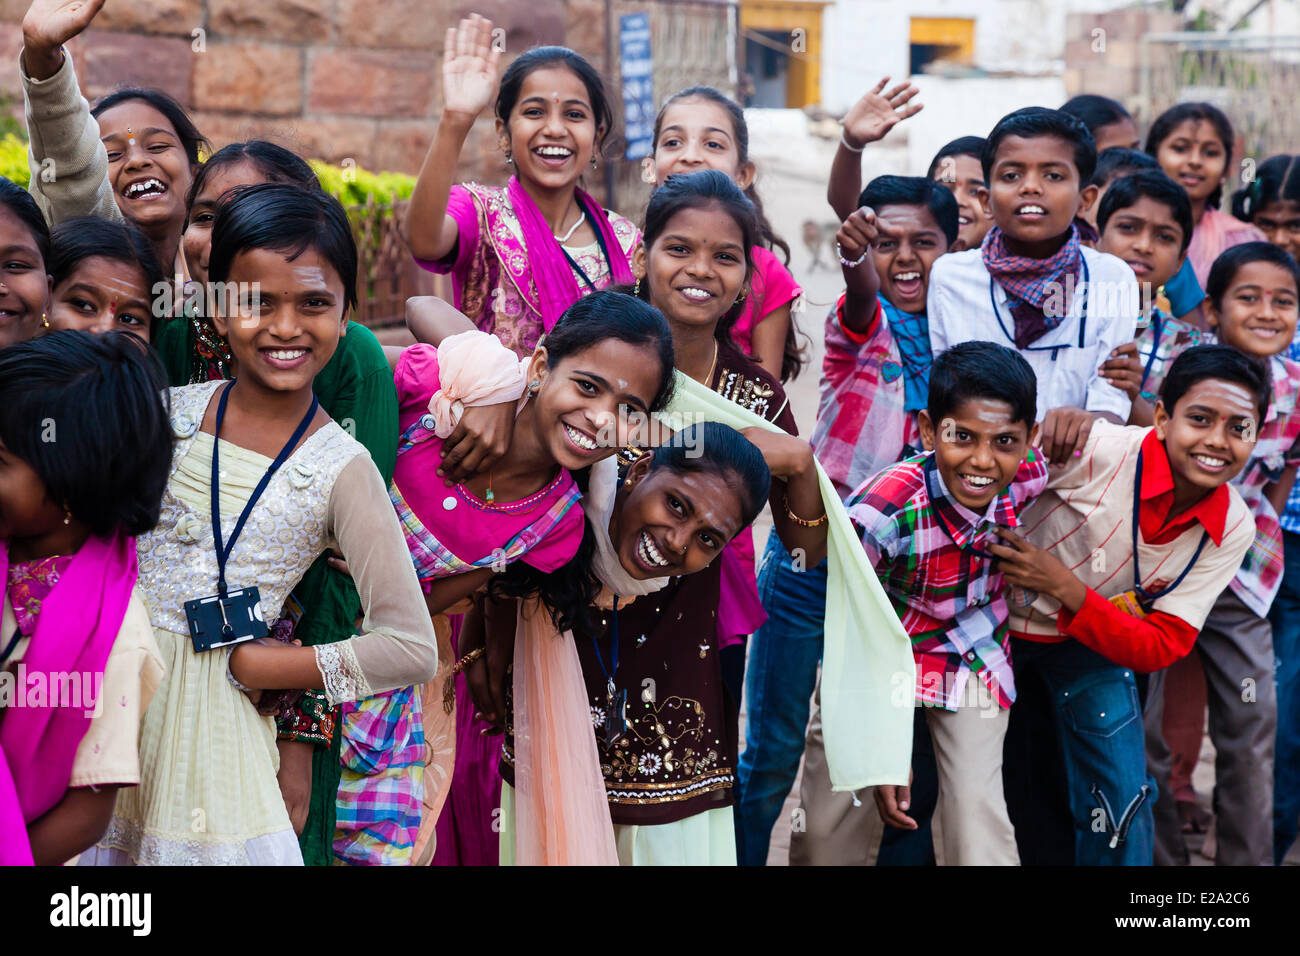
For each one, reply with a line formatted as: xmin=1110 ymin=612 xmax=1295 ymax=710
xmin=989 ymin=346 xmax=1270 ymax=865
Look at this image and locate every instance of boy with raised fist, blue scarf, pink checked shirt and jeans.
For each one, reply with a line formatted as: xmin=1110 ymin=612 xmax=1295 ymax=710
xmin=736 ymin=176 xmax=957 ymax=866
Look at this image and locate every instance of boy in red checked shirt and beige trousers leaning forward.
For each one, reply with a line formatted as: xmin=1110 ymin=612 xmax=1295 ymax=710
xmin=845 ymin=342 xmax=1048 ymax=865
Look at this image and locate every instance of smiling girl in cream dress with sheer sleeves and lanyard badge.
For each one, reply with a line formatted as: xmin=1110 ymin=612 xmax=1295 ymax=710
xmin=83 ymin=183 xmax=437 ymax=864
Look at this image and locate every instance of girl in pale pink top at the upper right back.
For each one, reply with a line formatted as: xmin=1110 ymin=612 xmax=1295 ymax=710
xmin=1147 ymin=103 xmax=1264 ymax=287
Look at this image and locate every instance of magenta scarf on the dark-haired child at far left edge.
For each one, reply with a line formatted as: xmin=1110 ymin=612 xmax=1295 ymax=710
xmin=0 ymin=535 xmax=138 ymax=832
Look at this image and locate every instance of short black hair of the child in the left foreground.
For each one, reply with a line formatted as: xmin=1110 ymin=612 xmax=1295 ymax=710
xmin=0 ymin=329 xmax=173 ymax=537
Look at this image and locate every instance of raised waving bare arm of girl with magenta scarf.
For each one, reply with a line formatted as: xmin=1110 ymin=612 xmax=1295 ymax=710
xmin=403 ymin=14 xmax=501 ymax=261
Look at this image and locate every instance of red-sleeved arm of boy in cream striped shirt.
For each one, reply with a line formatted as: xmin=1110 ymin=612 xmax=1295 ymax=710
xmin=989 ymin=528 xmax=1197 ymax=674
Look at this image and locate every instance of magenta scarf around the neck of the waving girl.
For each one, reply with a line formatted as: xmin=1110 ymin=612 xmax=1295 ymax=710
xmin=506 ymin=177 xmax=633 ymax=332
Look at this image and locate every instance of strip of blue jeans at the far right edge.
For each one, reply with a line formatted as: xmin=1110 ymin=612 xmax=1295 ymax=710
xmin=1269 ymin=531 xmax=1300 ymax=866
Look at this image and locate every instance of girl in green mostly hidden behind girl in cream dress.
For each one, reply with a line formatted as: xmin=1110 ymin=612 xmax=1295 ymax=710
xmin=155 ymin=139 xmax=398 ymax=866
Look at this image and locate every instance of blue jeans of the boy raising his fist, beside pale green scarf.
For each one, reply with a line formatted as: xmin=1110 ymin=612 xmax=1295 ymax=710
xmin=736 ymin=531 xmax=827 ymax=866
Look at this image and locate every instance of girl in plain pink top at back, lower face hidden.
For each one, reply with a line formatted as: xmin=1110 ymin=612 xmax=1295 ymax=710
xmin=645 ymin=86 xmax=803 ymax=382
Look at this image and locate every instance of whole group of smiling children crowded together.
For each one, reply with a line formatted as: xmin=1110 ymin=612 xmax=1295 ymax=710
xmin=0 ymin=3 xmax=1300 ymax=865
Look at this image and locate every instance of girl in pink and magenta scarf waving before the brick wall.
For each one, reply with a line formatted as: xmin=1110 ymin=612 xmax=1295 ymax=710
xmin=406 ymin=16 xmax=637 ymax=354
